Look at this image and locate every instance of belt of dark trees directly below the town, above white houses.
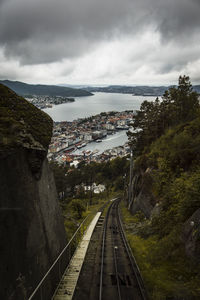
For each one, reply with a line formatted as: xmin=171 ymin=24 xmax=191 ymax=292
xmin=51 ymin=157 xmax=129 ymax=202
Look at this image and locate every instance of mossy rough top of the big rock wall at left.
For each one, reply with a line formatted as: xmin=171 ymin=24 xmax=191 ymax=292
xmin=0 ymin=84 xmax=53 ymax=151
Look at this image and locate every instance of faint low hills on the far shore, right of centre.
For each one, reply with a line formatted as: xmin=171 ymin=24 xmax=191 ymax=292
xmin=85 ymin=85 xmax=200 ymax=96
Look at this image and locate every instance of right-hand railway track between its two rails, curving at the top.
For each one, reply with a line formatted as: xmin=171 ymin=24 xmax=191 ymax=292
xmin=96 ymin=199 xmax=147 ymax=300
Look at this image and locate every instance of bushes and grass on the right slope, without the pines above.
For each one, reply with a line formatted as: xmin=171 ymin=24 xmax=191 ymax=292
xmin=119 ymin=118 xmax=200 ymax=299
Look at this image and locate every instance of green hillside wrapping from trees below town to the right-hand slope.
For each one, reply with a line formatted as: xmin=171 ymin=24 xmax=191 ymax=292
xmin=45 ymin=76 xmax=200 ymax=300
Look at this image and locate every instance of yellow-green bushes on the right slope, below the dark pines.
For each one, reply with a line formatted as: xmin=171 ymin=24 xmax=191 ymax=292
xmin=146 ymin=118 xmax=200 ymax=236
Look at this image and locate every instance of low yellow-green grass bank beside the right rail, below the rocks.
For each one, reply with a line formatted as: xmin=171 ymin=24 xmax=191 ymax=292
xmin=122 ymin=203 xmax=200 ymax=300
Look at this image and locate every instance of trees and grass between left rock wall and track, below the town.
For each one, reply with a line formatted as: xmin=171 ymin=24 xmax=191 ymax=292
xmin=50 ymin=158 xmax=129 ymax=238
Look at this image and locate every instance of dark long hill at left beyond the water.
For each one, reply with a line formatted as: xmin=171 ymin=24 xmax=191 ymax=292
xmin=0 ymin=80 xmax=92 ymax=97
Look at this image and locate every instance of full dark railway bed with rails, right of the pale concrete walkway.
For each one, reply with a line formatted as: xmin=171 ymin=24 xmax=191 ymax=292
xmin=73 ymin=199 xmax=147 ymax=300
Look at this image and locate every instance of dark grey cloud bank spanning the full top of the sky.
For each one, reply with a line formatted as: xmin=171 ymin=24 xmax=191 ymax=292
xmin=0 ymin=0 xmax=200 ymax=64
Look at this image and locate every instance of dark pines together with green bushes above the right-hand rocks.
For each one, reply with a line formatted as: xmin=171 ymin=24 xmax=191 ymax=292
xmin=131 ymin=76 xmax=200 ymax=235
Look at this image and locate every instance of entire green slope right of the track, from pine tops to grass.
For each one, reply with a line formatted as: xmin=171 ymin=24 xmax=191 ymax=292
xmin=124 ymin=76 xmax=200 ymax=299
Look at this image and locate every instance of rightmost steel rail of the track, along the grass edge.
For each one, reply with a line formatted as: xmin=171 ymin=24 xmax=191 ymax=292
xmin=117 ymin=201 xmax=148 ymax=300
